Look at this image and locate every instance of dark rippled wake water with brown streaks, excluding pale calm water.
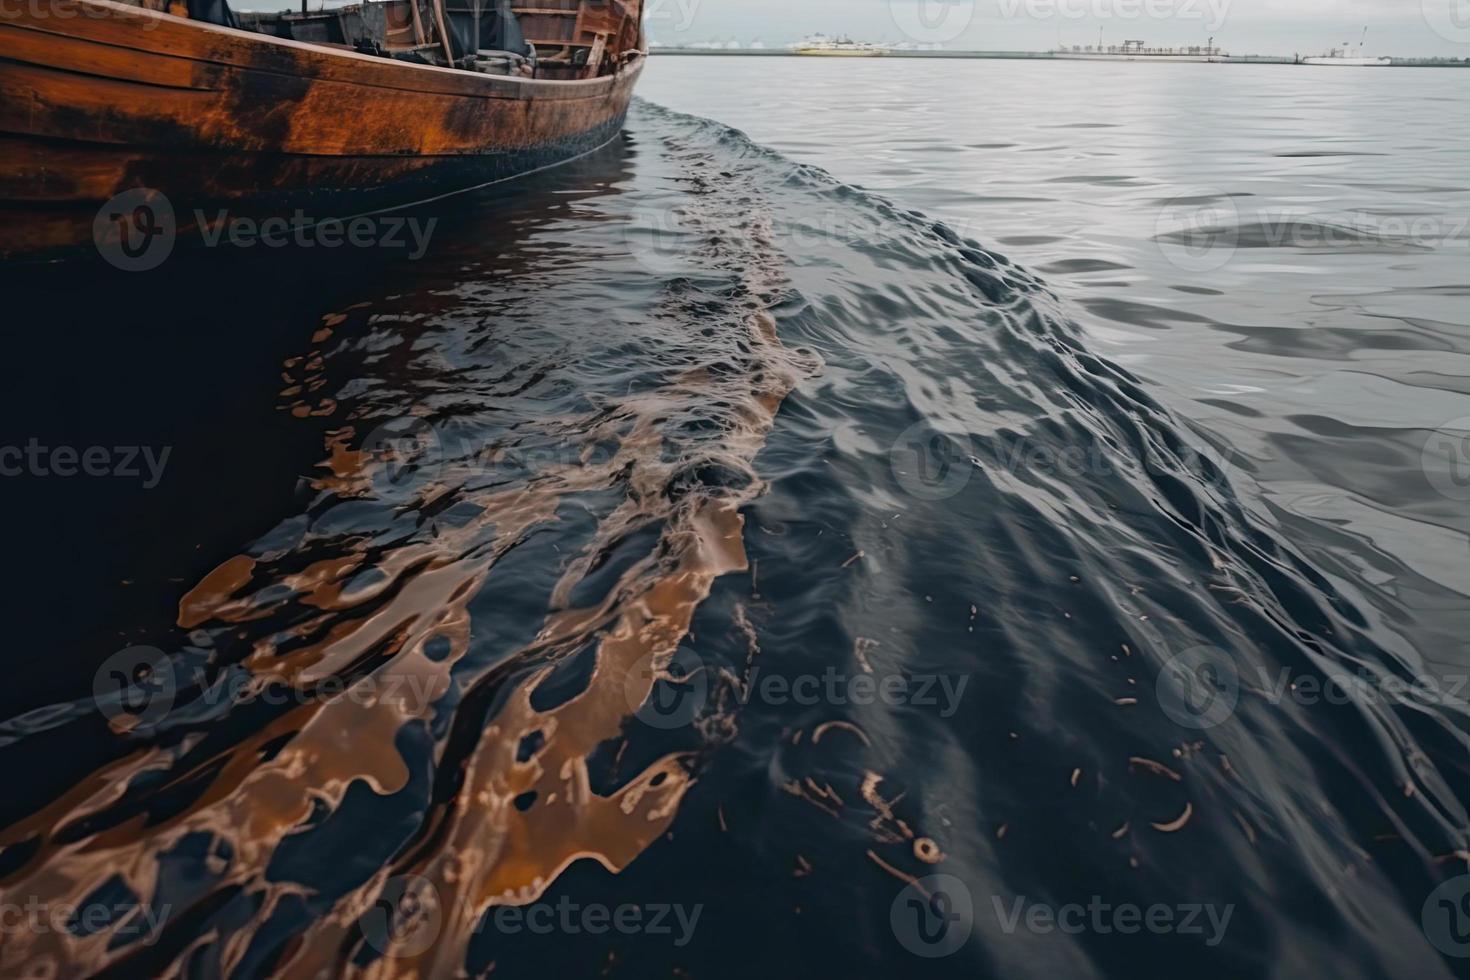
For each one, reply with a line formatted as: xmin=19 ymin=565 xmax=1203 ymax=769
xmin=0 ymin=76 xmax=1467 ymax=977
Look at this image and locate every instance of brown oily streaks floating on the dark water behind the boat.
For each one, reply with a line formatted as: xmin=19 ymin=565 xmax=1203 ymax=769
xmin=0 ymin=195 xmax=810 ymax=977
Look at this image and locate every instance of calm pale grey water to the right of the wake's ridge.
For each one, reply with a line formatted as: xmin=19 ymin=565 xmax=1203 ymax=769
xmin=644 ymin=57 xmax=1470 ymax=643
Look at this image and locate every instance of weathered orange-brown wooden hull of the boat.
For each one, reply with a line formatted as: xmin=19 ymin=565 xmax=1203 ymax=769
xmin=0 ymin=0 xmax=642 ymax=257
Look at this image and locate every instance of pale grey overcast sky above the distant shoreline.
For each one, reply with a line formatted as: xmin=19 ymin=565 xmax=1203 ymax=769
xmin=645 ymin=0 xmax=1470 ymax=56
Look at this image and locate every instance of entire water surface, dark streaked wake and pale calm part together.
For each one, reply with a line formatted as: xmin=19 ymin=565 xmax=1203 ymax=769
xmin=0 ymin=59 xmax=1470 ymax=977
